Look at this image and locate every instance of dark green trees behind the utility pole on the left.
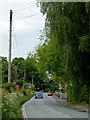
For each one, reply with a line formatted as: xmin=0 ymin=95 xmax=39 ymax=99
xmin=0 ymin=52 xmax=47 ymax=90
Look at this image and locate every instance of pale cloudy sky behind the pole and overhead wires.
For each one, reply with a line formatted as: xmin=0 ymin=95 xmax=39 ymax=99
xmin=0 ymin=0 xmax=45 ymax=60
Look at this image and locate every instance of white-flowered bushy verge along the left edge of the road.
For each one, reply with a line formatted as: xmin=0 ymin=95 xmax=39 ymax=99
xmin=2 ymin=89 xmax=35 ymax=120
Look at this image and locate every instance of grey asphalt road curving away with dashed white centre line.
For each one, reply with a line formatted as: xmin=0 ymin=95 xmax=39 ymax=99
xmin=22 ymin=93 xmax=88 ymax=118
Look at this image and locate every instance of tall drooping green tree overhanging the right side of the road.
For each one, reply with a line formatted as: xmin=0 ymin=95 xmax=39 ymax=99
xmin=37 ymin=2 xmax=90 ymax=103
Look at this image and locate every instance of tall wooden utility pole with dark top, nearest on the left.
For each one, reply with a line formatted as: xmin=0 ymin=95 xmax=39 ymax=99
xmin=8 ymin=10 xmax=12 ymax=83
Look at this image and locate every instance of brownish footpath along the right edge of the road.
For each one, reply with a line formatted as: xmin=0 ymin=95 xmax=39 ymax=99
xmin=53 ymin=95 xmax=90 ymax=113
